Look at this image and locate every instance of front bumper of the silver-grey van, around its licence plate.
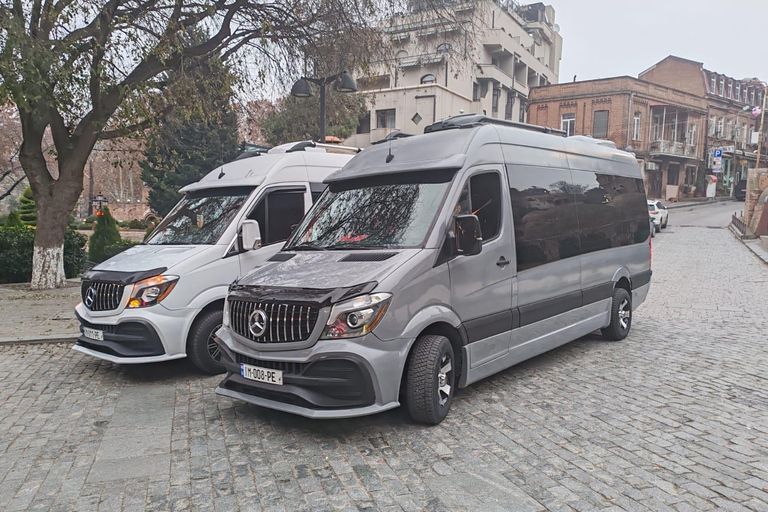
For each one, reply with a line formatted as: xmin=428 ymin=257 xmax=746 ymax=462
xmin=216 ymin=328 xmax=411 ymax=418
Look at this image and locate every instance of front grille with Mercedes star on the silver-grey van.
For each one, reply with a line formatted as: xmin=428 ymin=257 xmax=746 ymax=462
xmin=229 ymin=300 xmax=318 ymax=343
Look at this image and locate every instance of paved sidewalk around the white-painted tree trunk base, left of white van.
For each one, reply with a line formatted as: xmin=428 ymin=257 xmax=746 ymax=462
xmin=0 ymin=279 xmax=80 ymax=343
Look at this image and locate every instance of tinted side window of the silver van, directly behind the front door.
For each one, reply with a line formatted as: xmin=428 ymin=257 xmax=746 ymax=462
xmin=507 ymin=165 xmax=579 ymax=271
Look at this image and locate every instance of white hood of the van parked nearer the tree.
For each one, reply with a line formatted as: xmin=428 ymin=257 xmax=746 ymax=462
xmin=93 ymin=245 xmax=211 ymax=272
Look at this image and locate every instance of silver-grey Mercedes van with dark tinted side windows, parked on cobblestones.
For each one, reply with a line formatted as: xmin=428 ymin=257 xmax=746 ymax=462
xmin=216 ymin=115 xmax=651 ymax=424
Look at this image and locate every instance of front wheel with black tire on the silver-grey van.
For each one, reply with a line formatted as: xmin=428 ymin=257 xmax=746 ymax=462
xmin=406 ymin=334 xmax=456 ymax=425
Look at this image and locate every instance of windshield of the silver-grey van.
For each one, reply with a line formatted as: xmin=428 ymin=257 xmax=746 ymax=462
xmin=283 ymin=182 xmax=450 ymax=251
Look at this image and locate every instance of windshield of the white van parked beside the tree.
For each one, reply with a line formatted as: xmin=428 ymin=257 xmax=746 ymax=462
xmin=146 ymin=187 xmax=253 ymax=245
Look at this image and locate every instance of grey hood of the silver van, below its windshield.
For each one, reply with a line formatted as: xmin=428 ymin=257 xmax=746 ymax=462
xmin=237 ymin=249 xmax=421 ymax=289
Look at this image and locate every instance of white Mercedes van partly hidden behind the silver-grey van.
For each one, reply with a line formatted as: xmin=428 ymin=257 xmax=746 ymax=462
xmin=73 ymin=141 xmax=358 ymax=373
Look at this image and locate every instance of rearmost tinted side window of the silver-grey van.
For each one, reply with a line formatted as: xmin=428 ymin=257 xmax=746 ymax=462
xmin=572 ymin=171 xmax=650 ymax=254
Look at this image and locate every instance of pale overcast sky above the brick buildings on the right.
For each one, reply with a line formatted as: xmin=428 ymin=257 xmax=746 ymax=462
xmin=544 ymin=0 xmax=768 ymax=82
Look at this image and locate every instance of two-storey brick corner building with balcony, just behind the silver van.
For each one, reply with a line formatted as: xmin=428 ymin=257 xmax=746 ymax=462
xmin=528 ymin=76 xmax=707 ymax=199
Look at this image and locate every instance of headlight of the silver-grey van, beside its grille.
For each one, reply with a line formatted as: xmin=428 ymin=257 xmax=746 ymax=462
xmin=320 ymin=293 xmax=392 ymax=340
